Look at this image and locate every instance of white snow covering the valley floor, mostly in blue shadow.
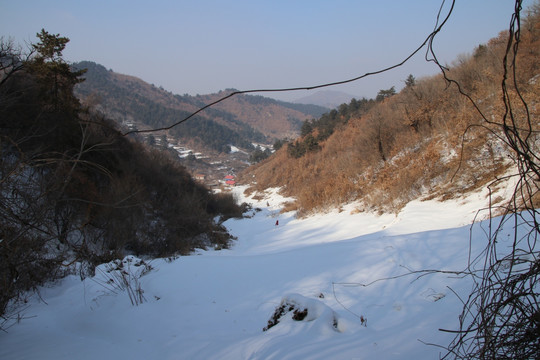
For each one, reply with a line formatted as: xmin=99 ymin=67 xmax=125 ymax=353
xmin=0 ymin=187 xmax=520 ymax=360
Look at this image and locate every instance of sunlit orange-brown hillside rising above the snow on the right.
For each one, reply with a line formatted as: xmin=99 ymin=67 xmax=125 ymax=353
xmin=244 ymin=6 xmax=540 ymax=212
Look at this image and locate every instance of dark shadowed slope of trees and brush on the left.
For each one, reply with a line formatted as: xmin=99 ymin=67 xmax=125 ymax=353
xmin=0 ymin=30 xmax=241 ymax=317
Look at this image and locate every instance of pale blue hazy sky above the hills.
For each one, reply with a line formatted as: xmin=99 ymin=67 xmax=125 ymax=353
xmin=0 ymin=0 xmax=533 ymax=100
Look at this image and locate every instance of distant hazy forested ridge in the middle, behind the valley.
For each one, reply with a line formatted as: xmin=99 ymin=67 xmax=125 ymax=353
xmin=74 ymin=61 xmax=327 ymax=152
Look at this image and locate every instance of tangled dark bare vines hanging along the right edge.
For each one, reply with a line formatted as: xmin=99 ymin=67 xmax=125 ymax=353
xmin=444 ymin=0 xmax=540 ymax=359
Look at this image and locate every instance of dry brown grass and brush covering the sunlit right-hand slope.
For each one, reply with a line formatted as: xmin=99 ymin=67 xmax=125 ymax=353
xmin=240 ymin=13 xmax=540 ymax=214
